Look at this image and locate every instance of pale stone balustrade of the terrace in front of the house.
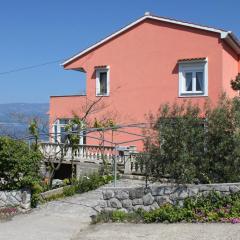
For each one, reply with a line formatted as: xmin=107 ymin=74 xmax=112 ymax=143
xmin=40 ymin=142 xmax=142 ymax=174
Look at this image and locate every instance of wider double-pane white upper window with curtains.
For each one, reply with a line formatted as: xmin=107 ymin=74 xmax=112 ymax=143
xmin=179 ymin=59 xmax=208 ymax=97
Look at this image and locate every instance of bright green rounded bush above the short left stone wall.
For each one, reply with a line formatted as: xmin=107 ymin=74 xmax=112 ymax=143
xmin=0 ymin=137 xmax=41 ymax=190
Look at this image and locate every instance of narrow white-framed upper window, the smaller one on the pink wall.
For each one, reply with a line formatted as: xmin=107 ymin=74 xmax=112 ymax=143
xmin=96 ymin=67 xmax=110 ymax=96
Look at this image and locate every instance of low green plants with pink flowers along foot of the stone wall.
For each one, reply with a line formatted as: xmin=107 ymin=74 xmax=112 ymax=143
xmin=93 ymin=192 xmax=240 ymax=223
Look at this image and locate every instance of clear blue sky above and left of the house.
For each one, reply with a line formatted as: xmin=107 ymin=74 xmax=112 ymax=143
xmin=0 ymin=0 xmax=240 ymax=103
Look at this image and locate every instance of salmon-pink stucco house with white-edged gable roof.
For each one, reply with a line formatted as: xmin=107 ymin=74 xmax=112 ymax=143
xmin=49 ymin=13 xmax=240 ymax=150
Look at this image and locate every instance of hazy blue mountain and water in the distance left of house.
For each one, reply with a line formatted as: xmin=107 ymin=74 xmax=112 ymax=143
xmin=0 ymin=103 xmax=49 ymax=138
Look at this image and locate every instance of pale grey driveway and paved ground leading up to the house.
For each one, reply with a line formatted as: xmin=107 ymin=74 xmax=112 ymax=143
xmin=0 ymin=180 xmax=240 ymax=240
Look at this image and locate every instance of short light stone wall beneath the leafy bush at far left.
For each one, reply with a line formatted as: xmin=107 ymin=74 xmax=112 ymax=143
xmin=0 ymin=190 xmax=31 ymax=210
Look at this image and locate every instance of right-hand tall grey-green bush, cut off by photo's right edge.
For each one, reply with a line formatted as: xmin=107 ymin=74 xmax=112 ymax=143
xmin=204 ymin=95 xmax=240 ymax=182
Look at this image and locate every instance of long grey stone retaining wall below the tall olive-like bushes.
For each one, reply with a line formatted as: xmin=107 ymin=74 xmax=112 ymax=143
xmin=100 ymin=183 xmax=240 ymax=212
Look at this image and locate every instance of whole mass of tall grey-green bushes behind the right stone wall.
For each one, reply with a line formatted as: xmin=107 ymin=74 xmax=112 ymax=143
xmin=139 ymin=95 xmax=240 ymax=183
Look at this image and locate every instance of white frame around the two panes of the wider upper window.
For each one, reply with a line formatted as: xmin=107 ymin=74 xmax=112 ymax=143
xmin=178 ymin=59 xmax=208 ymax=97
